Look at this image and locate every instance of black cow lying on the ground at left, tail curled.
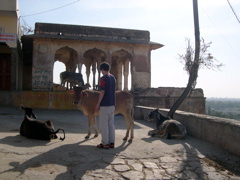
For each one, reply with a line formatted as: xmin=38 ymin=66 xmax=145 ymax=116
xmin=20 ymin=105 xmax=65 ymax=141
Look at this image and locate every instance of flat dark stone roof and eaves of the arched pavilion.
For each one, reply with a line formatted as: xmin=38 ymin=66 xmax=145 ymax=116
xmin=25 ymin=23 xmax=163 ymax=49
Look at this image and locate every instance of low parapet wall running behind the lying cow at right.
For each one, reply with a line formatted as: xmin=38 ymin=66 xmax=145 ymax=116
xmin=134 ymin=106 xmax=240 ymax=156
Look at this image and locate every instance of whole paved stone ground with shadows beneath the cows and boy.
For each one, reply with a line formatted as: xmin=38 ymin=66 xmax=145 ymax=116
xmin=0 ymin=107 xmax=240 ymax=180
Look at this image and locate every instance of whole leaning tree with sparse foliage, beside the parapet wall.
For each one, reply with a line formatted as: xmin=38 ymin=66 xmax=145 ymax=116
xmin=168 ymin=0 xmax=223 ymax=118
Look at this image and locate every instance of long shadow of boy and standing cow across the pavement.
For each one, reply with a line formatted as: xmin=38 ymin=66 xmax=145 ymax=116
xmin=2 ymin=140 xmax=129 ymax=179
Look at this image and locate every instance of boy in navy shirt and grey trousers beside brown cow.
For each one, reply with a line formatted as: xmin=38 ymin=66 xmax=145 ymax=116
xmin=95 ymin=62 xmax=116 ymax=149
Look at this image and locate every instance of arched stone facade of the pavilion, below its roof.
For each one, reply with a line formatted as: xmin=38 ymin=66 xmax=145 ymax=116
xmin=30 ymin=39 xmax=154 ymax=90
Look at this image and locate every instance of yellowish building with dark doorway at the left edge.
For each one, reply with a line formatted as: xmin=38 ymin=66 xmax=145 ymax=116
xmin=0 ymin=0 xmax=22 ymax=90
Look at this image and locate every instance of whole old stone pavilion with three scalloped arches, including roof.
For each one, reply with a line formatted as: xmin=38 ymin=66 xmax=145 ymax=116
xmin=22 ymin=23 xmax=163 ymax=91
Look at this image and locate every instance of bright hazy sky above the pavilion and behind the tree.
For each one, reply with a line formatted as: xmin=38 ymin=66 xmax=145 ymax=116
xmin=18 ymin=0 xmax=240 ymax=98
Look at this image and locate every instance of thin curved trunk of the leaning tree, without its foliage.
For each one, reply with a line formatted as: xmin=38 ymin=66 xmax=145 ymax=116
xmin=168 ymin=0 xmax=200 ymax=118
